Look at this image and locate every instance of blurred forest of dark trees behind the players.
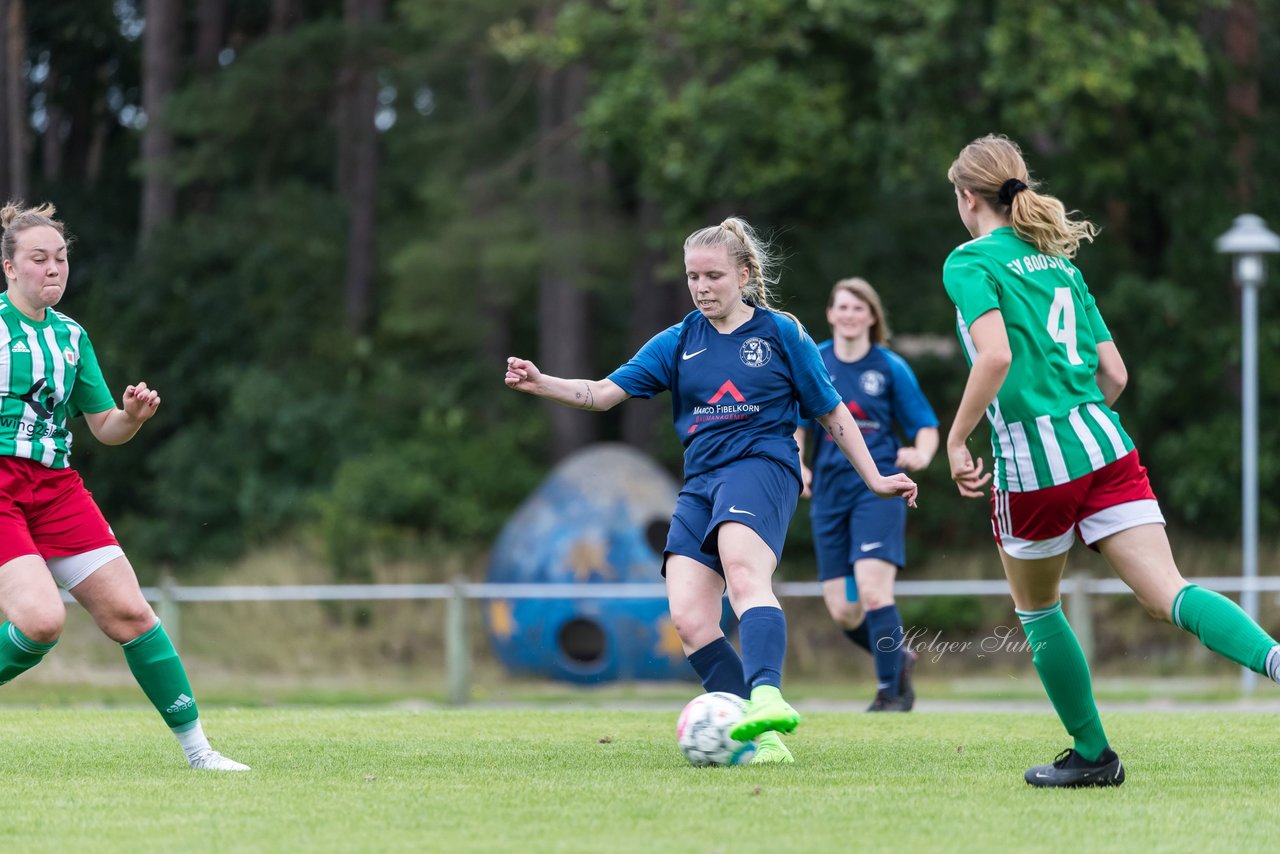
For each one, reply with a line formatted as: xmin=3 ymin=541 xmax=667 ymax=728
xmin=0 ymin=0 xmax=1280 ymax=681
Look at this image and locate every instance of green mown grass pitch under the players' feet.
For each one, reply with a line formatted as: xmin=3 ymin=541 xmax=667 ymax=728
xmin=0 ymin=707 xmax=1280 ymax=854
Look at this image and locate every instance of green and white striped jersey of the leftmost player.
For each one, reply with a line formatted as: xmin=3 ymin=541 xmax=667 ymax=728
xmin=0 ymin=294 xmax=115 ymax=469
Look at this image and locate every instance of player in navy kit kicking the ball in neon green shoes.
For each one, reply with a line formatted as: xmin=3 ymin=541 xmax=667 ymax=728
xmin=506 ymin=218 xmax=916 ymax=763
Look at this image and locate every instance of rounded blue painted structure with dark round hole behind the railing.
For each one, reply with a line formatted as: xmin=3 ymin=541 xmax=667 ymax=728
xmin=485 ymin=443 xmax=694 ymax=682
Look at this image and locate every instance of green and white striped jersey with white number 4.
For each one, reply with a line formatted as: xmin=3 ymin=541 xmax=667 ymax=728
xmin=942 ymin=227 xmax=1133 ymax=492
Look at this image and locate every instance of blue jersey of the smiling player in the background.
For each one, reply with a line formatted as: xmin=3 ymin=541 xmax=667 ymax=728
xmin=808 ymin=341 xmax=938 ymax=504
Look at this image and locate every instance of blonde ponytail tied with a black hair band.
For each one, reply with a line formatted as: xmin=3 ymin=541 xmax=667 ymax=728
xmin=947 ymin=133 xmax=1098 ymax=257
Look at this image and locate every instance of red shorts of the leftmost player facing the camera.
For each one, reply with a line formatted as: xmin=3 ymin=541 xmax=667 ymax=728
xmin=0 ymin=457 xmax=119 ymax=566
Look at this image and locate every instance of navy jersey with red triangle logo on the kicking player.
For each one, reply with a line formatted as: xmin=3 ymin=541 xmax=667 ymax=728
xmin=608 ymin=307 xmax=847 ymax=480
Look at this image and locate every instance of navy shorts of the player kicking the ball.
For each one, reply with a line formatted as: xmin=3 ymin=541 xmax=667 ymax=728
xmin=662 ymin=457 xmax=800 ymax=575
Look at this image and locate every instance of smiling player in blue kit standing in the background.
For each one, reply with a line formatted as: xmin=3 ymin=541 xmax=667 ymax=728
xmin=796 ymin=278 xmax=938 ymax=712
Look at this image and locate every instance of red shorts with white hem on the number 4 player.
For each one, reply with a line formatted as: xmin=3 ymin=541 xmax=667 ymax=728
xmin=991 ymin=451 xmax=1165 ymax=560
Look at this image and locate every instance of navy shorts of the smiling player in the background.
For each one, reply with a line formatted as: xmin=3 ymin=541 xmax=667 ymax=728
xmin=810 ymin=489 xmax=906 ymax=581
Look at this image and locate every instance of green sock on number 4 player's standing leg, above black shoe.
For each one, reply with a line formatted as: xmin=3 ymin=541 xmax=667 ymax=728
xmin=1016 ymin=602 xmax=1107 ymax=762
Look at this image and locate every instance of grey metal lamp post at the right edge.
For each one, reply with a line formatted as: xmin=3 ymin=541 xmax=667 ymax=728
xmin=1216 ymin=214 xmax=1280 ymax=694
